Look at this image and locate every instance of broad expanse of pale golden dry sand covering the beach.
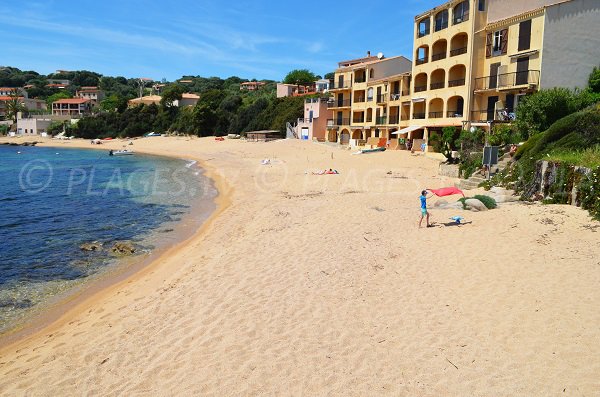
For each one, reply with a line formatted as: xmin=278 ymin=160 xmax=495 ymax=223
xmin=0 ymin=137 xmax=600 ymax=396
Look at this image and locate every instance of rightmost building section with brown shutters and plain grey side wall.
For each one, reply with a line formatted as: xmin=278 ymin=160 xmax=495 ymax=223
xmin=470 ymin=0 xmax=600 ymax=126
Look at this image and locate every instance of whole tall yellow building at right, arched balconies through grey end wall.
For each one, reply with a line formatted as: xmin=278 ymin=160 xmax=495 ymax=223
xmin=404 ymin=0 xmax=600 ymax=147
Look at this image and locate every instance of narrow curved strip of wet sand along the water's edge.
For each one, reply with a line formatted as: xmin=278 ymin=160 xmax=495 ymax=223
xmin=0 ymin=138 xmax=231 ymax=356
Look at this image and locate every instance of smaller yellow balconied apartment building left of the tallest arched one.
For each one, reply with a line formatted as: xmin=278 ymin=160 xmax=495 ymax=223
xmin=327 ymin=53 xmax=411 ymax=145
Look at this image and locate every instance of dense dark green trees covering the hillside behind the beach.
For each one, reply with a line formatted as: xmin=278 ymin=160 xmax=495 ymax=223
xmin=0 ymin=67 xmax=308 ymax=138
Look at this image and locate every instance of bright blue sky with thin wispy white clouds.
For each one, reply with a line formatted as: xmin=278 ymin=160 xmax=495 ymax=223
xmin=0 ymin=0 xmax=444 ymax=81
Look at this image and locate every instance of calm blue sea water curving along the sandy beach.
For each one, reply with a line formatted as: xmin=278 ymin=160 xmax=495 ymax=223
xmin=0 ymin=146 xmax=217 ymax=334
